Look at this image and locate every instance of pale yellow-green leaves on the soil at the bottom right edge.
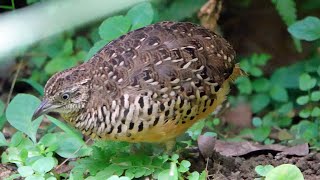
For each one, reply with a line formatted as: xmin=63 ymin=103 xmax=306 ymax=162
xmin=255 ymin=164 xmax=304 ymax=180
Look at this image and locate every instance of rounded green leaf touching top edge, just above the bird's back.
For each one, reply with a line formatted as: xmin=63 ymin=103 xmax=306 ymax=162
xmin=127 ymin=2 xmax=153 ymax=30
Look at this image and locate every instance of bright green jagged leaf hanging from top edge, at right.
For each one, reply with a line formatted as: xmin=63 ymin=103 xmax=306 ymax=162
xmin=272 ymin=0 xmax=297 ymax=26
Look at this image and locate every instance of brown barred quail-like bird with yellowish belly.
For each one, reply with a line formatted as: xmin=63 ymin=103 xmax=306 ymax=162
xmin=34 ymin=22 xmax=242 ymax=145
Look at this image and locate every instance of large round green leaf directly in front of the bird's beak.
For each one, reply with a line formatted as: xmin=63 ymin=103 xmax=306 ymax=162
xmin=6 ymin=94 xmax=42 ymax=142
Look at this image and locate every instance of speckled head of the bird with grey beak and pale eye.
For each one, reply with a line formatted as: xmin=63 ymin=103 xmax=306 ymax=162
xmin=33 ymin=66 xmax=91 ymax=119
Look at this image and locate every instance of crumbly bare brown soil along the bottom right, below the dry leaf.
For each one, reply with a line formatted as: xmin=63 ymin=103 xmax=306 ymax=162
xmin=188 ymin=152 xmax=320 ymax=180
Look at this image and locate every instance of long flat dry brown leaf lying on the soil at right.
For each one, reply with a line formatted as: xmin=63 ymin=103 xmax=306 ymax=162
xmin=214 ymin=140 xmax=309 ymax=156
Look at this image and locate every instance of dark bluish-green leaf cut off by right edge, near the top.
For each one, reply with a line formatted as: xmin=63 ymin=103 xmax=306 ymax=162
xmin=288 ymin=16 xmax=320 ymax=41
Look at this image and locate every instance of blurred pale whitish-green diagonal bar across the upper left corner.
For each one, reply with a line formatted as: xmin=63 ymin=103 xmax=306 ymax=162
xmin=0 ymin=0 xmax=149 ymax=62
